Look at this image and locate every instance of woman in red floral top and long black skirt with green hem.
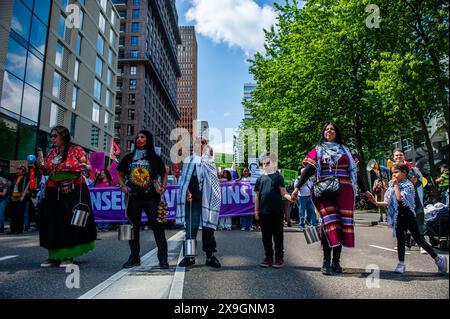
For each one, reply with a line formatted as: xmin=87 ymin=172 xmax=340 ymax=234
xmin=38 ymin=126 xmax=97 ymax=267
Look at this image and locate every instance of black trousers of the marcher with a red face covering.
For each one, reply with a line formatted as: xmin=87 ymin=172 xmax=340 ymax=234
xmin=127 ymin=196 xmax=167 ymax=262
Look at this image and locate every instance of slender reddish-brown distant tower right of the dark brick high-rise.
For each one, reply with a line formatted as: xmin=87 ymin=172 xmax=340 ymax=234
xmin=177 ymin=26 xmax=198 ymax=141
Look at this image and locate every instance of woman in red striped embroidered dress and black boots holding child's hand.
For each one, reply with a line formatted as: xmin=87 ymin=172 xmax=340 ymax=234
xmin=292 ymin=123 xmax=357 ymax=275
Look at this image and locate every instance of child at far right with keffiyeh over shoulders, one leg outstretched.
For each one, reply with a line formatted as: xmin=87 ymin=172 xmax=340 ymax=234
xmin=367 ymin=163 xmax=447 ymax=274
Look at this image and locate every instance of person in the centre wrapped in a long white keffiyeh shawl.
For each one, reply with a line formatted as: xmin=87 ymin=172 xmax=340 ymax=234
xmin=176 ymin=137 xmax=222 ymax=268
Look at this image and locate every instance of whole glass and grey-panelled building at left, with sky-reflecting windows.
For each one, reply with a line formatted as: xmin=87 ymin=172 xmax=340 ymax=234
xmin=0 ymin=0 xmax=119 ymax=169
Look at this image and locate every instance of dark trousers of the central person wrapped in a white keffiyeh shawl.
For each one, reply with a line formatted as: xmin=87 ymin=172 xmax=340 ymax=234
xmin=185 ymin=198 xmax=217 ymax=257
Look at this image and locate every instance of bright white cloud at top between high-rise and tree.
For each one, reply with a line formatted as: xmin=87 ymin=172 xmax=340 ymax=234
xmin=186 ymin=0 xmax=276 ymax=55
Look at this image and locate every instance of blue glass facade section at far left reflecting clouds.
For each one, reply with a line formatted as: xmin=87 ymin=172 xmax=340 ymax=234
xmin=0 ymin=0 xmax=51 ymax=168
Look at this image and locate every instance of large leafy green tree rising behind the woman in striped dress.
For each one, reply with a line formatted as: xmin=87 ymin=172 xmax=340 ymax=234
xmin=246 ymin=0 xmax=400 ymax=189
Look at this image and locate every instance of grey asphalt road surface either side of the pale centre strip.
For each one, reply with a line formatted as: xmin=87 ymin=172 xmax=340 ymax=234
xmin=0 ymin=214 xmax=449 ymax=299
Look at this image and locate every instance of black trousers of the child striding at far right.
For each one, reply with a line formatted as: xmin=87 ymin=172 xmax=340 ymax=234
xmin=395 ymin=205 xmax=437 ymax=261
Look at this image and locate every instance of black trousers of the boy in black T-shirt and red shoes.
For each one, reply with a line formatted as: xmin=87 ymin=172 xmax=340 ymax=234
xmin=259 ymin=212 xmax=284 ymax=258
